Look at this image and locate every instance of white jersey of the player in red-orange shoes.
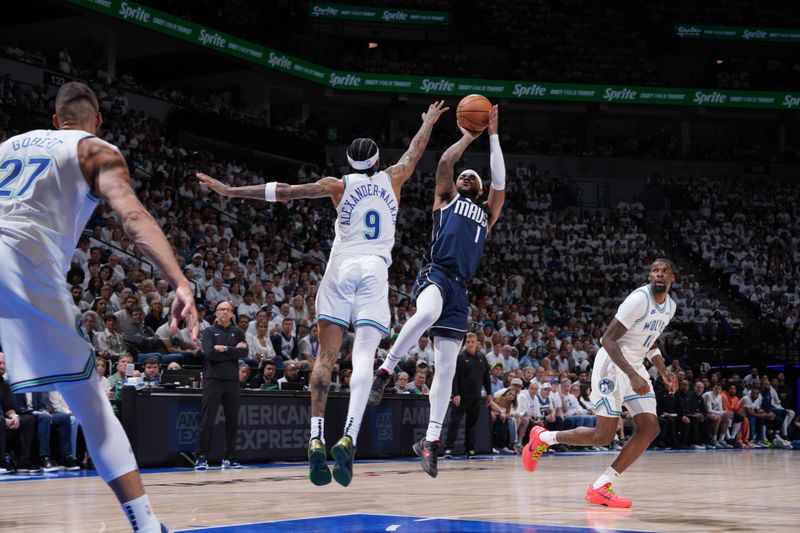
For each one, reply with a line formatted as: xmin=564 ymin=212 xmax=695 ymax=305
xmin=614 ymin=285 xmax=675 ymax=366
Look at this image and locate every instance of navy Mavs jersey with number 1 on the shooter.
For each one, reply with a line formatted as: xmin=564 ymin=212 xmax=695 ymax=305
xmin=424 ymin=194 xmax=489 ymax=282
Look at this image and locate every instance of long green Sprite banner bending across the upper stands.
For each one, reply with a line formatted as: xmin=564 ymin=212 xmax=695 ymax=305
xmin=66 ymin=0 xmax=800 ymax=109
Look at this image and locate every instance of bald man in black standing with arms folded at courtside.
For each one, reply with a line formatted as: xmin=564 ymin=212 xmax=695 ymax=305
xmin=195 ymin=301 xmax=248 ymax=470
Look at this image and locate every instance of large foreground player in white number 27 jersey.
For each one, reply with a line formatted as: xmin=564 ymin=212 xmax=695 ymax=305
xmin=0 ymin=82 xmax=197 ymax=532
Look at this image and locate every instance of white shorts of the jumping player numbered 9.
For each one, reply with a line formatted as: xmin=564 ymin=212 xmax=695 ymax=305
xmin=317 ymin=255 xmax=390 ymax=335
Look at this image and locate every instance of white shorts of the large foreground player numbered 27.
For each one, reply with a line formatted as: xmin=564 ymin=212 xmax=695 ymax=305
xmin=0 ymin=236 xmax=94 ymax=392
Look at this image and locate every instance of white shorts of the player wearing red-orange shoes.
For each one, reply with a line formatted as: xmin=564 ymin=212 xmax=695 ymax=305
xmin=589 ymin=348 xmax=656 ymax=418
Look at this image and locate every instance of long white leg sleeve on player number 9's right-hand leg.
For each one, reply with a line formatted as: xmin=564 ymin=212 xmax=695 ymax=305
xmin=343 ymin=326 xmax=383 ymax=446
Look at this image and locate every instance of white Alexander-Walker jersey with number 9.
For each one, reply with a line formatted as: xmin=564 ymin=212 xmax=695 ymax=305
xmin=331 ymin=171 xmax=397 ymax=266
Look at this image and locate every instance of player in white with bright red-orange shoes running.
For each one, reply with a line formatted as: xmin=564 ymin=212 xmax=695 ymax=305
xmin=522 ymin=259 xmax=676 ymax=507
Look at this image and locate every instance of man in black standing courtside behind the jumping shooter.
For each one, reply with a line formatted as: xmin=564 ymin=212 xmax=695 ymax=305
xmin=444 ymin=333 xmax=492 ymax=457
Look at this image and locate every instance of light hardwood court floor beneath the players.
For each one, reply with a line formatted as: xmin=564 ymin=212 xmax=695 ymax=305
xmin=0 ymin=450 xmax=800 ymax=532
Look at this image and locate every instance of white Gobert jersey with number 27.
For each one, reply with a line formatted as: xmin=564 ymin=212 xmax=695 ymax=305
xmin=0 ymin=130 xmax=99 ymax=272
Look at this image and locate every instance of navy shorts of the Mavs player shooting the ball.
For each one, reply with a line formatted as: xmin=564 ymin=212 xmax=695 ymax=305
xmin=414 ymin=265 xmax=469 ymax=340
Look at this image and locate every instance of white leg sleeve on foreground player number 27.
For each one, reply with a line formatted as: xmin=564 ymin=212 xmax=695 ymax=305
xmin=56 ymin=374 xmax=136 ymax=483
